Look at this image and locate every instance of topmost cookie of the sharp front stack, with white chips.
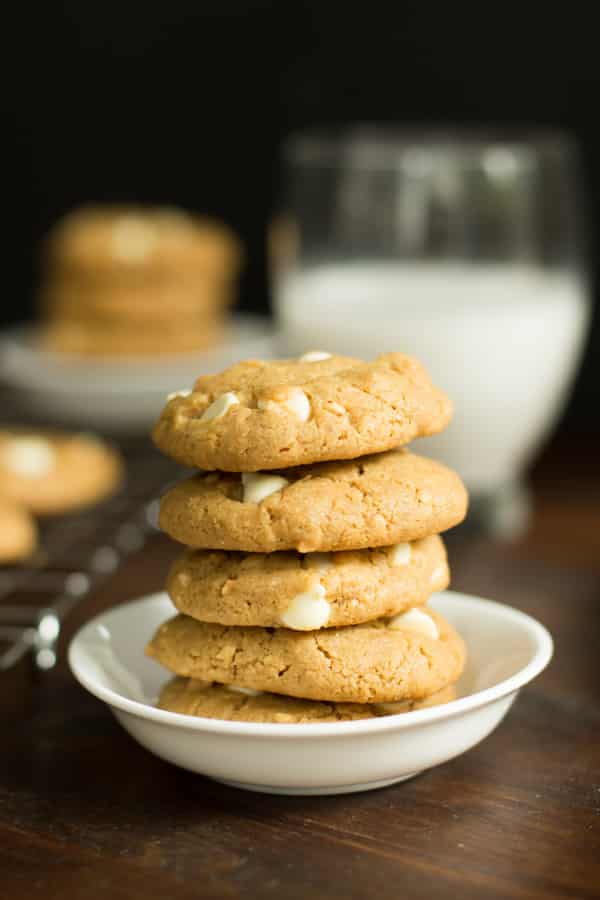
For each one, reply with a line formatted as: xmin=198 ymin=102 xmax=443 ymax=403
xmin=153 ymin=353 xmax=452 ymax=472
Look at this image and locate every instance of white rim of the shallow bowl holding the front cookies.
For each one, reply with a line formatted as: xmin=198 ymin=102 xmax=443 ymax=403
xmin=68 ymin=591 xmax=554 ymax=740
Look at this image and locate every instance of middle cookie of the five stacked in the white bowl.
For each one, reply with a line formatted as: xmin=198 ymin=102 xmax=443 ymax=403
xmin=167 ymin=535 xmax=449 ymax=631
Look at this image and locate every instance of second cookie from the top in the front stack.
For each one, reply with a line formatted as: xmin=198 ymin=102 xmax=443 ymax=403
xmin=160 ymin=450 xmax=467 ymax=553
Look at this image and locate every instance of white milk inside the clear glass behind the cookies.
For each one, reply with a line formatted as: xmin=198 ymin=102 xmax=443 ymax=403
xmin=276 ymin=262 xmax=588 ymax=493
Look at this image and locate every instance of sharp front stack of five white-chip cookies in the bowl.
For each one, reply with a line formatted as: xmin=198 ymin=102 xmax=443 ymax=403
xmin=147 ymin=352 xmax=467 ymax=722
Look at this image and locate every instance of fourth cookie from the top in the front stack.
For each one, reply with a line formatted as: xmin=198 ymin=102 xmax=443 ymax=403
xmin=146 ymin=608 xmax=465 ymax=703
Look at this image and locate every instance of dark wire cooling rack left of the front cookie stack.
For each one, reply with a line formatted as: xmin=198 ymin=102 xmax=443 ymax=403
xmin=0 ymin=445 xmax=181 ymax=672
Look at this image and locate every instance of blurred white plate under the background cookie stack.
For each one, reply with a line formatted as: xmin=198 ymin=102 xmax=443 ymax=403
xmin=0 ymin=316 xmax=274 ymax=432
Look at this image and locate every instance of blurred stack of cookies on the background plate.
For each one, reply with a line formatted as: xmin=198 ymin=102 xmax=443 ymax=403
xmin=40 ymin=207 xmax=240 ymax=356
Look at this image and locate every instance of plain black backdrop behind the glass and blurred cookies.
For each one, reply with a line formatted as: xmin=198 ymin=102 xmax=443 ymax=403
xmin=2 ymin=0 xmax=600 ymax=430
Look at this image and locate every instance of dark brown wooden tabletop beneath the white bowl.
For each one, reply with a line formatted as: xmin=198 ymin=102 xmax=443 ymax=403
xmin=0 ymin=443 xmax=600 ymax=900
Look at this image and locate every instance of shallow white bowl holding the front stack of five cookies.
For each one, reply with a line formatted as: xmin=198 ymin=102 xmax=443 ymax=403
xmin=69 ymin=591 xmax=552 ymax=794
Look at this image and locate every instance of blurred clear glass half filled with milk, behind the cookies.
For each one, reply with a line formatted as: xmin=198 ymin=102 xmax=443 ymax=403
xmin=270 ymin=128 xmax=589 ymax=534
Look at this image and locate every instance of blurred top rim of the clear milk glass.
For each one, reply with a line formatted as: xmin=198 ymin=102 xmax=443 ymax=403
xmin=282 ymin=123 xmax=578 ymax=168
